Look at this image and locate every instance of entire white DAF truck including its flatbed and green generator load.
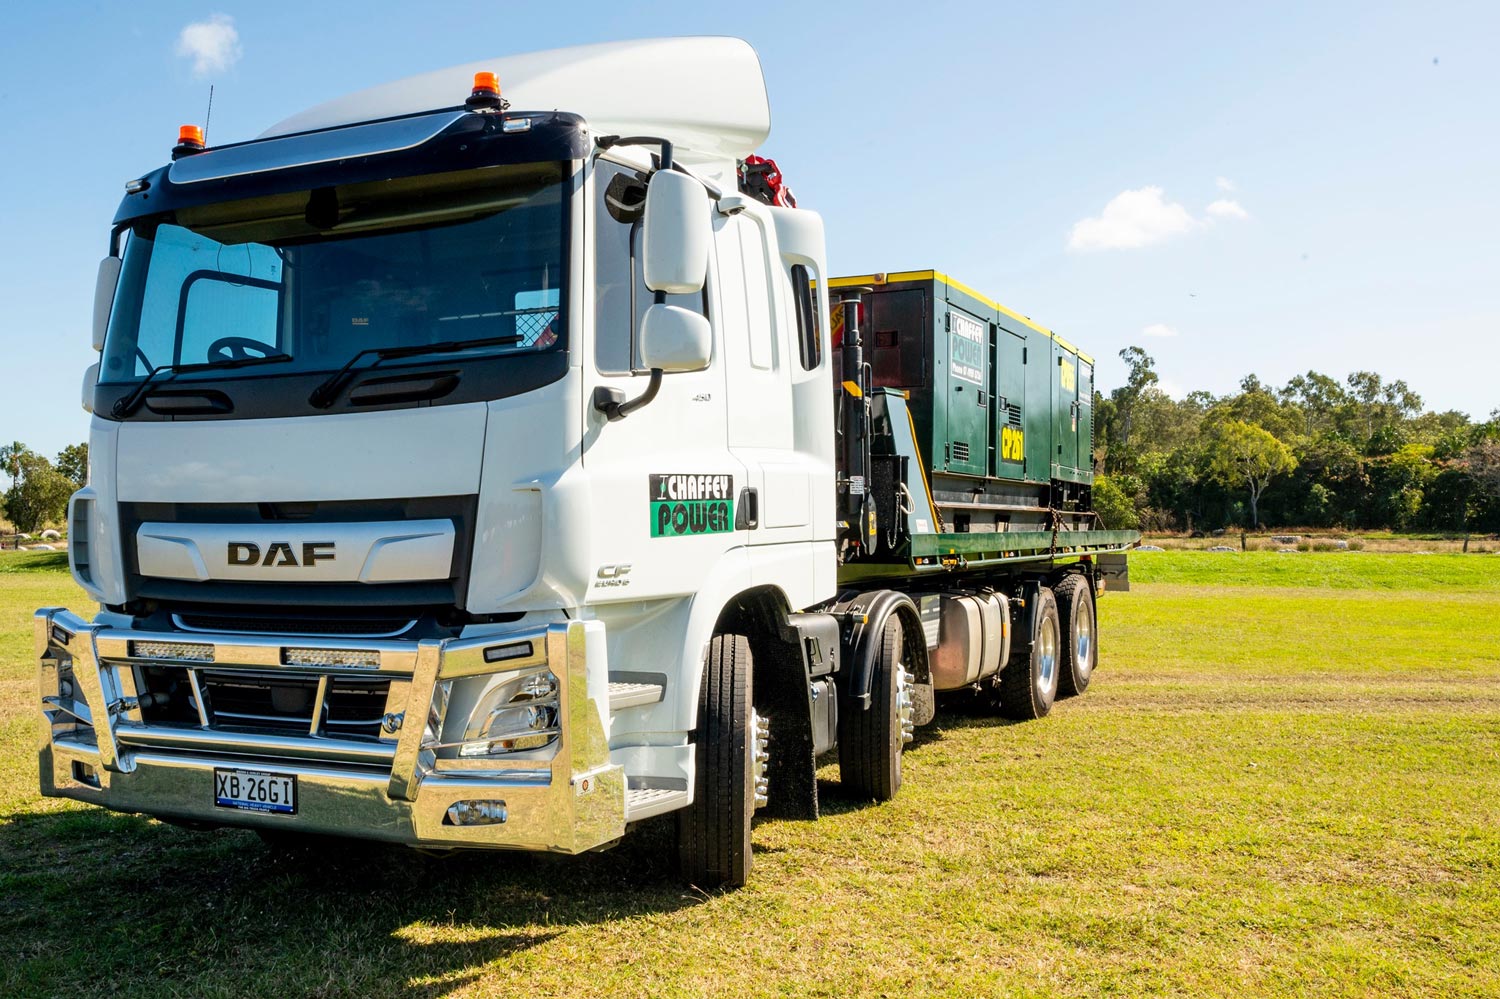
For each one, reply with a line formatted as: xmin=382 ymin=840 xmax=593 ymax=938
xmin=36 ymin=38 xmax=1136 ymax=887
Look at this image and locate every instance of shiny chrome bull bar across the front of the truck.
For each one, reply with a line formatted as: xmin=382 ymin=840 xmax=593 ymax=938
xmin=36 ymin=608 xmax=626 ymax=854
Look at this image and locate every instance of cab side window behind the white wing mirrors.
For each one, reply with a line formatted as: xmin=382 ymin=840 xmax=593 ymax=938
xmin=594 ymin=159 xmax=708 ymax=375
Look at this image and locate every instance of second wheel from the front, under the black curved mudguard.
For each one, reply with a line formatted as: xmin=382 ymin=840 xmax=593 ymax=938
xmin=839 ymin=614 xmax=917 ymax=801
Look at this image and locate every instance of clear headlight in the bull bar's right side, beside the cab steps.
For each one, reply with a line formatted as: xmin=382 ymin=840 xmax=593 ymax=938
xmin=440 ymin=666 xmax=561 ymax=758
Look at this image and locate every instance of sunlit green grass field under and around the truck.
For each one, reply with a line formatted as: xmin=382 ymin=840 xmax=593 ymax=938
xmin=0 ymin=552 xmax=1500 ymax=998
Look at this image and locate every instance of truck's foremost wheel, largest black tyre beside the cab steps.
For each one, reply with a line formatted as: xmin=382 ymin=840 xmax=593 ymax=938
xmin=677 ymin=635 xmax=765 ymax=890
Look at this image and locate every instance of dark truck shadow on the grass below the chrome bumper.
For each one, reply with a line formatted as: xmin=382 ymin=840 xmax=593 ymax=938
xmin=0 ymin=809 xmax=708 ymax=996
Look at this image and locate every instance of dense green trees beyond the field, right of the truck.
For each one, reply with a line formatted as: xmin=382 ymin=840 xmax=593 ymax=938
xmin=1094 ymin=347 xmax=1500 ymax=533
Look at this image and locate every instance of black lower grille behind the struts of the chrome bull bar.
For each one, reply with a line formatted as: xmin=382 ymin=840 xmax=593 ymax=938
xmin=143 ymin=666 xmax=390 ymax=738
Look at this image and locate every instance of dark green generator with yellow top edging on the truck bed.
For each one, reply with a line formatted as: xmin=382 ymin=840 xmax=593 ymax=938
xmin=830 ymin=270 xmax=1128 ymax=567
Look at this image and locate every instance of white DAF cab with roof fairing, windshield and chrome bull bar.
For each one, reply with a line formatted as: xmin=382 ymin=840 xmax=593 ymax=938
xmin=38 ymin=39 xmax=836 ymax=881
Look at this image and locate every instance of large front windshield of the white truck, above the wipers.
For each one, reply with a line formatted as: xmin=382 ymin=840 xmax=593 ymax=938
xmin=101 ymin=164 xmax=570 ymax=382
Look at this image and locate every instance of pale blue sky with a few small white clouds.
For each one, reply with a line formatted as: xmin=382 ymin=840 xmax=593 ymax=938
xmin=0 ymin=0 xmax=1500 ymax=455
